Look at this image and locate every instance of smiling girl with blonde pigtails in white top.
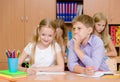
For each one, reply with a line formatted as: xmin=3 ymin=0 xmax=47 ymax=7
xmin=18 ymin=19 xmax=64 ymax=74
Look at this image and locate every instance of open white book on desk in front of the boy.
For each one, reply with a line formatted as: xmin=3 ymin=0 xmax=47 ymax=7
xmin=77 ymin=71 xmax=114 ymax=77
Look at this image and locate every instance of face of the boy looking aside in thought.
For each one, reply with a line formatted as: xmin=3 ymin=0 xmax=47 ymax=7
xmin=73 ymin=22 xmax=91 ymax=41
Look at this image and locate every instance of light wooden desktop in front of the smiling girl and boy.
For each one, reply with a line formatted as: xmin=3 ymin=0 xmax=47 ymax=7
xmin=16 ymin=72 xmax=120 ymax=82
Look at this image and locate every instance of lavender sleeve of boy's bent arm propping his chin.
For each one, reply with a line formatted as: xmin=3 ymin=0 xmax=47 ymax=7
xmin=81 ymin=39 xmax=108 ymax=70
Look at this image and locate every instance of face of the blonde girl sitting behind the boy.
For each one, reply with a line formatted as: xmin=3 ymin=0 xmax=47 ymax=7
xmin=95 ymin=20 xmax=106 ymax=33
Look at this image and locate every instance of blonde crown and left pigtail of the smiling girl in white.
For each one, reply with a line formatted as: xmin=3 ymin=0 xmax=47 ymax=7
xmin=29 ymin=19 xmax=56 ymax=64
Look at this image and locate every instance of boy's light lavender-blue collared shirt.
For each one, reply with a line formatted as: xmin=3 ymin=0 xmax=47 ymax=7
xmin=68 ymin=35 xmax=109 ymax=71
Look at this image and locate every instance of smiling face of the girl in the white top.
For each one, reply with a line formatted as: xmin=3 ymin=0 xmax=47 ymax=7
xmin=39 ymin=26 xmax=55 ymax=46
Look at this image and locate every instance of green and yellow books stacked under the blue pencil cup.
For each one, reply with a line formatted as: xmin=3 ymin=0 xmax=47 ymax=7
xmin=0 ymin=70 xmax=27 ymax=78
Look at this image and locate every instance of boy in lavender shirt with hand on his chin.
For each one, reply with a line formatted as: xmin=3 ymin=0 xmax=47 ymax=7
xmin=68 ymin=15 xmax=109 ymax=75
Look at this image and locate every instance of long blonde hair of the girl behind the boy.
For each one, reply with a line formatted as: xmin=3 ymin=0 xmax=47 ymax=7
xmin=93 ymin=13 xmax=109 ymax=48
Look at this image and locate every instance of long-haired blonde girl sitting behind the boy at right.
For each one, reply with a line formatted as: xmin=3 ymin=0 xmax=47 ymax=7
xmin=93 ymin=13 xmax=117 ymax=70
